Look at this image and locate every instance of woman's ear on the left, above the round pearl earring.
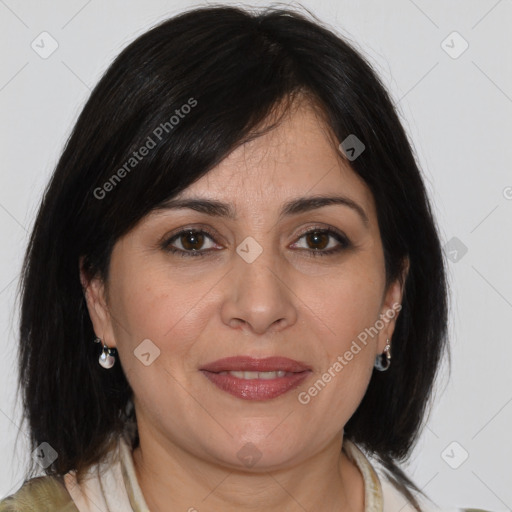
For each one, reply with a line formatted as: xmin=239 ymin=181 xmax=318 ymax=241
xmin=79 ymin=256 xmax=116 ymax=348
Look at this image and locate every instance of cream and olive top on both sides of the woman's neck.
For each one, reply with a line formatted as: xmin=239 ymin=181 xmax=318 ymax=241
xmin=0 ymin=436 xmax=469 ymax=512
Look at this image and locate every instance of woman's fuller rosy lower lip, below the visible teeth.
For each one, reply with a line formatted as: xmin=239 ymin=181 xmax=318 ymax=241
xmin=201 ymin=370 xmax=311 ymax=400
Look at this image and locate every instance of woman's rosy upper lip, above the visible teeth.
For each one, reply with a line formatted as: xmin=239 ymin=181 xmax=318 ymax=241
xmin=200 ymin=356 xmax=311 ymax=373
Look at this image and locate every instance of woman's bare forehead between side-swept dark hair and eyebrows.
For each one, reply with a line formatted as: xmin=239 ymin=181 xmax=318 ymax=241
xmin=176 ymin=102 xmax=374 ymax=216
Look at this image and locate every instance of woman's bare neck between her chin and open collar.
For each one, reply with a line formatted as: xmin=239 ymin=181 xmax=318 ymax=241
xmin=133 ymin=428 xmax=364 ymax=512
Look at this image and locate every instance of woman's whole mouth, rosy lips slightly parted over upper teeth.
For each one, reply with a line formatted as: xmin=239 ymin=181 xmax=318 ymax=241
xmin=200 ymin=356 xmax=312 ymax=400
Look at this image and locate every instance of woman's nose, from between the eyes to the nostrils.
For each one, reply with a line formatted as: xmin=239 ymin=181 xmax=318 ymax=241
xmin=221 ymin=241 xmax=297 ymax=334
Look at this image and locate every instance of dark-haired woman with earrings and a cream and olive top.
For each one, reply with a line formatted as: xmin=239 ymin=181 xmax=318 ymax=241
xmin=0 ymin=6 xmax=468 ymax=512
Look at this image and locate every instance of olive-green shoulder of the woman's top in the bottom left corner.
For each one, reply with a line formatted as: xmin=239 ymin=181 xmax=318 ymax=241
xmin=0 ymin=476 xmax=78 ymax=512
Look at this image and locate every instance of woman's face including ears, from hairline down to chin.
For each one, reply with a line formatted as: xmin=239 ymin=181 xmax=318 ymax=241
xmin=87 ymin=99 xmax=401 ymax=469
